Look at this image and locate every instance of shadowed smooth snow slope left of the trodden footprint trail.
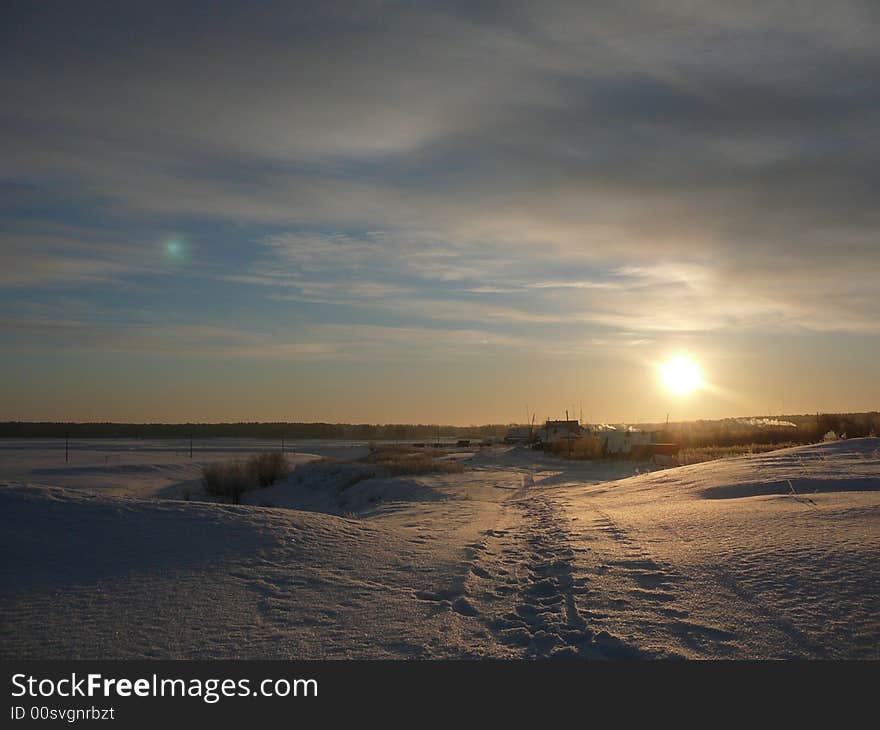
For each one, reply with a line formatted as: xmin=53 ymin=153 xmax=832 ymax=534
xmin=0 ymin=485 xmax=496 ymax=658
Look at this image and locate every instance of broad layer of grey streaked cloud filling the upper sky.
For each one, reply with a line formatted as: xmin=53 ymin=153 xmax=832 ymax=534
xmin=0 ymin=1 xmax=880 ymax=342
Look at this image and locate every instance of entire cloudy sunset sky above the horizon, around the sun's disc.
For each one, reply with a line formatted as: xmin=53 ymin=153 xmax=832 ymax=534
xmin=0 ymin=0 xmax=880 ymax=424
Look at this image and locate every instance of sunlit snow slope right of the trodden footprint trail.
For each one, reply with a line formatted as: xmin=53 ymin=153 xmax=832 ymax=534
xmin=554 ymin=439 xmax=880 ymax=658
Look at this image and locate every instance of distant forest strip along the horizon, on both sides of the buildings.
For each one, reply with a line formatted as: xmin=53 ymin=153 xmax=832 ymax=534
xmin=0 ymin=411 xmax=880 ymax=446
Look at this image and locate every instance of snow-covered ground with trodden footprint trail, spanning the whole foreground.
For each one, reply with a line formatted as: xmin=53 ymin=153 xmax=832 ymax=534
xmin=0 ymin=439 xmax=880 ymax=659
